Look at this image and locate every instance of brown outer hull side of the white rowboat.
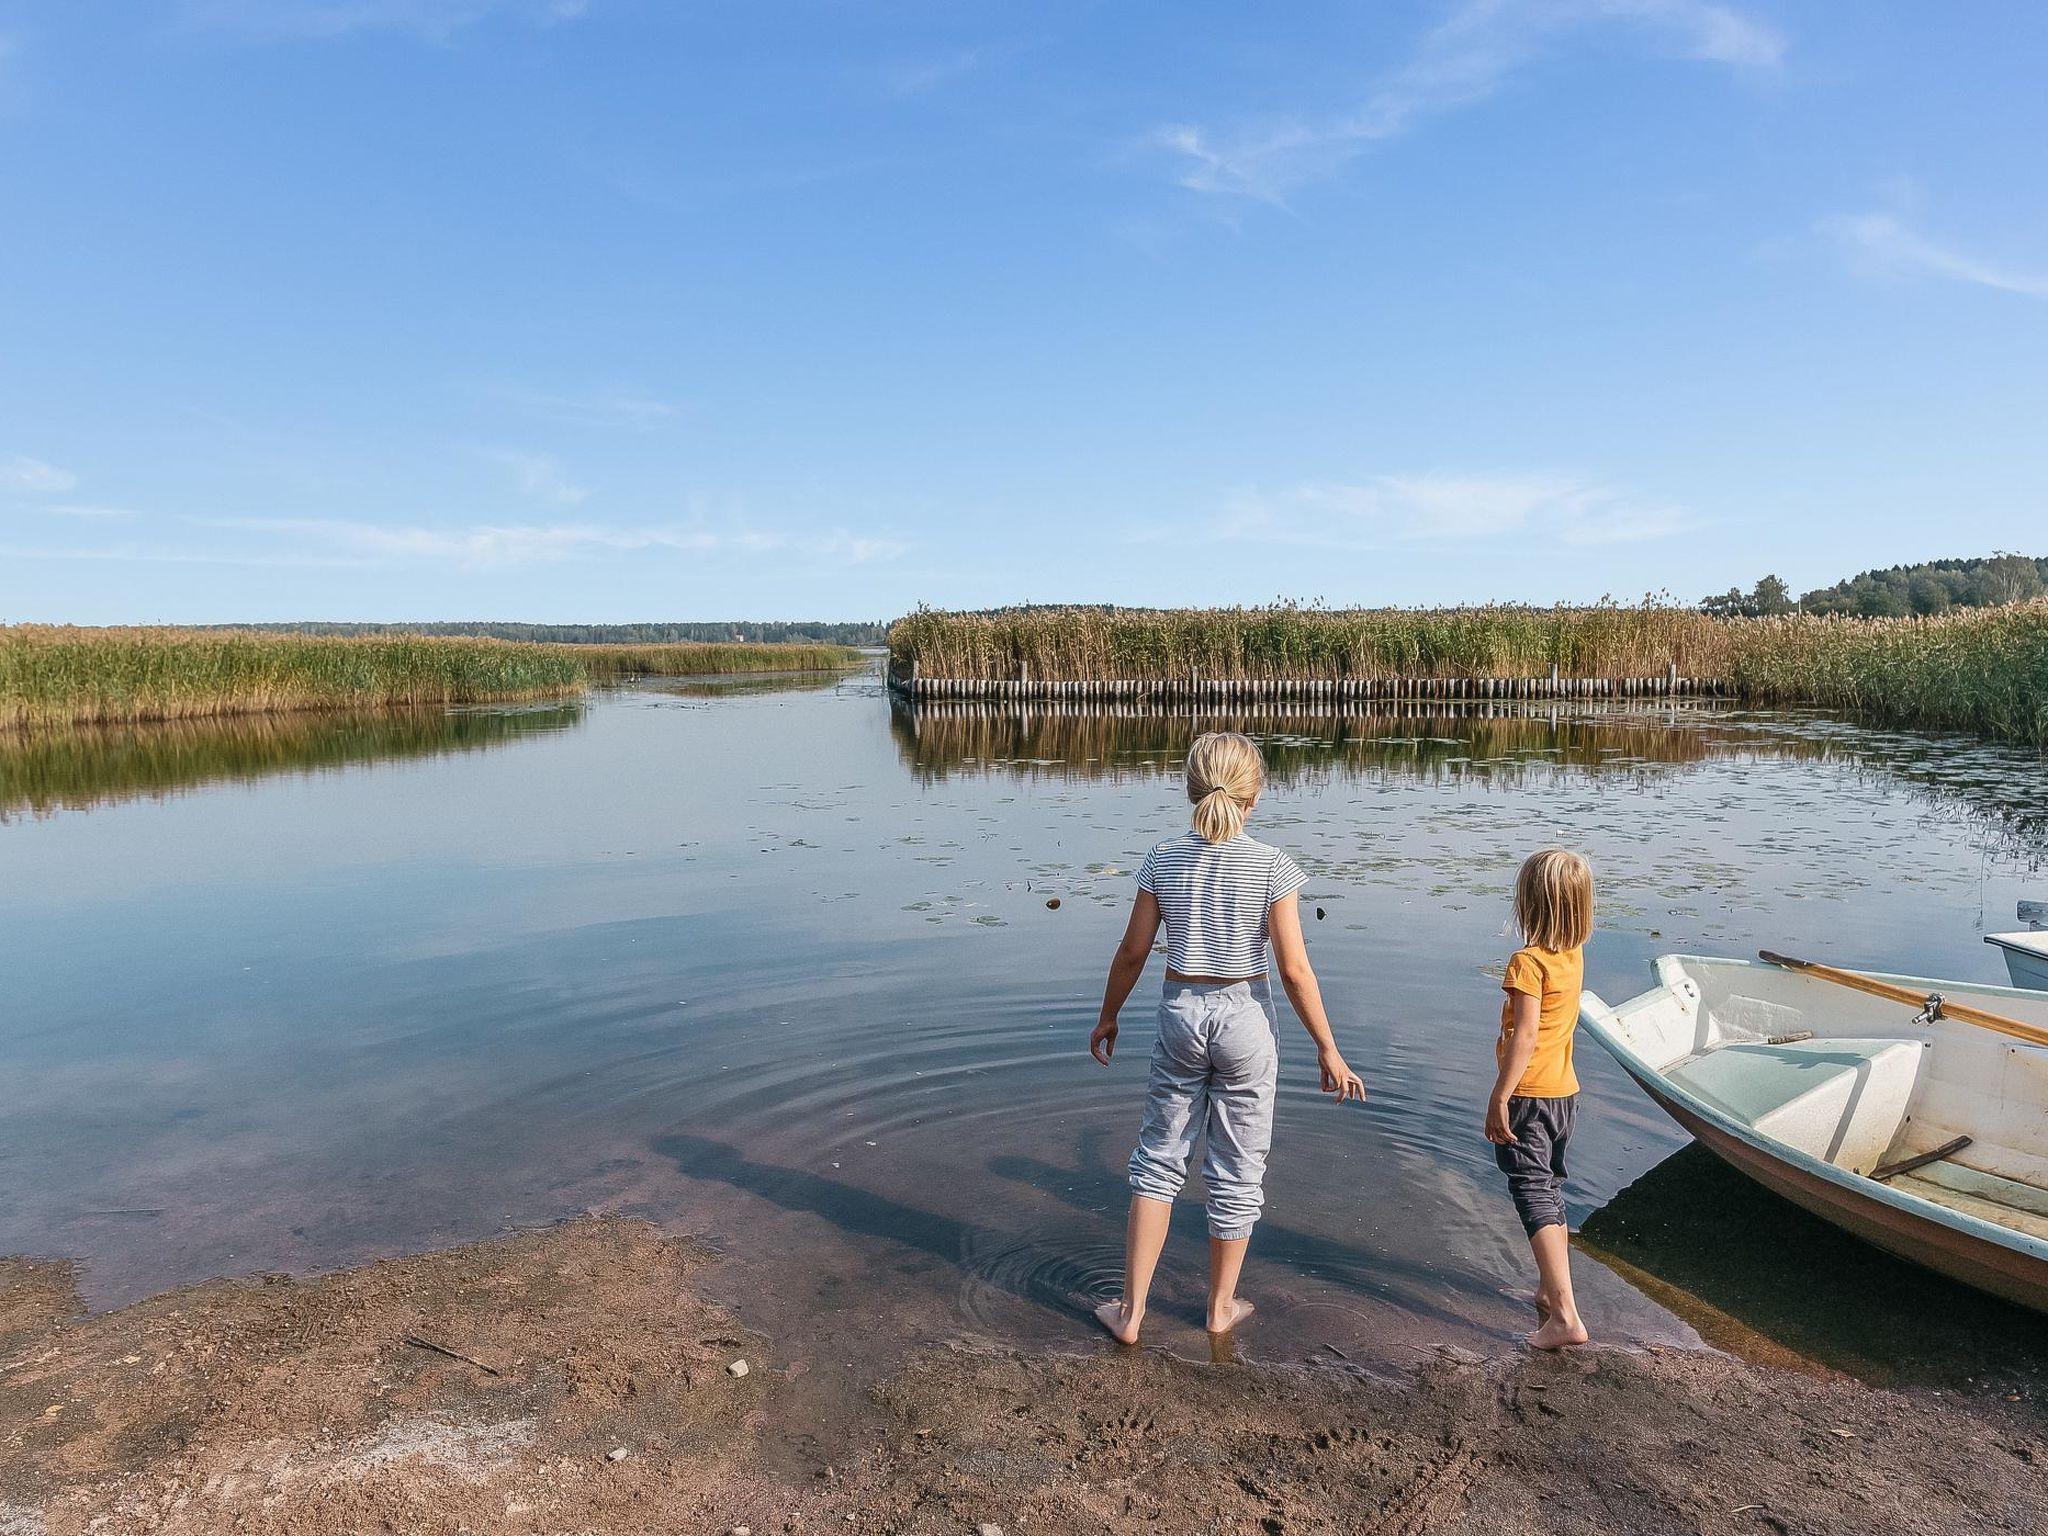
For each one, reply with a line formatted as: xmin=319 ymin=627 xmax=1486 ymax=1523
xmin=1622 ymin=1061 xmax=2048 ymax=1313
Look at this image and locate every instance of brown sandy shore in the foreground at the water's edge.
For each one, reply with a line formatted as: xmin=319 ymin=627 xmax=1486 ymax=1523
xmin=0 ymin=1221 xmax=2048 ymax=1536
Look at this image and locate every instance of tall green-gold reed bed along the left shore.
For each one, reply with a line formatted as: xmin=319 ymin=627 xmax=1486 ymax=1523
xmin=0 ymin=625 xmax=860 ymax=729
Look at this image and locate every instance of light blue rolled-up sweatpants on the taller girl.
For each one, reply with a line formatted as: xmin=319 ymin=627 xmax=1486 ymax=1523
xmin=1130 ymin=979 xmax=1280 ymax=1237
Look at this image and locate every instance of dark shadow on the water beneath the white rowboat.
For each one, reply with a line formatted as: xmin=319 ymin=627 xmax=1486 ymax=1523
xmin=1577 ymin=1145 xmax=2048 ymax=1397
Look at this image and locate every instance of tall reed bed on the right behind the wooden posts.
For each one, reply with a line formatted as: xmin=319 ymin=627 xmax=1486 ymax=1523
xmin=889 ymin=602 xmax=2048 ymax=748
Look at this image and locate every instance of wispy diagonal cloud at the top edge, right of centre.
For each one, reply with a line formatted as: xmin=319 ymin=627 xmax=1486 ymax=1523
xmin=1153 ymin=0 xmax=1786 ymax=203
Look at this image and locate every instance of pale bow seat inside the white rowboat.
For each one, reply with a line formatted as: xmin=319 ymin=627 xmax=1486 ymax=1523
xmin=1667 ymin=1036 xmax=1927 ymax=1174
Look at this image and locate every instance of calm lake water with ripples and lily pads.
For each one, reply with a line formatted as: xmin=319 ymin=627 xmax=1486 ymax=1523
xmin=0 ymin=676 xmax=2048 ymax=1391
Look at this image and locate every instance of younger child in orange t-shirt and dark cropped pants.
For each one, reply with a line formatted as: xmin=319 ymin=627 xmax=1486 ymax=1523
xmin=1487 ymin=848 xmax=1593 ymax=1350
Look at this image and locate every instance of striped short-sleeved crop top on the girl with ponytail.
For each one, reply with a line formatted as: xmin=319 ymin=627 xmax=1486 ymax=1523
xmin=1139 ymin=831 xmax=1307 ymax=981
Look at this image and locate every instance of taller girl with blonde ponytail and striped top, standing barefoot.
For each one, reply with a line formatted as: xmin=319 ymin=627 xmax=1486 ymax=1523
xmin=1087 ymin=731 xmax=1366 ymax=1343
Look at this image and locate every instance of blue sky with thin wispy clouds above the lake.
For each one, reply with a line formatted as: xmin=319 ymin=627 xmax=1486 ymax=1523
xmin=0 ymin=0 xmax=2048 ymax=623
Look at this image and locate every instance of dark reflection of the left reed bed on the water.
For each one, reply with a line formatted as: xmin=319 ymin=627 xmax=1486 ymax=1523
xmin=0 ymin=705 xmax=584 ymax=821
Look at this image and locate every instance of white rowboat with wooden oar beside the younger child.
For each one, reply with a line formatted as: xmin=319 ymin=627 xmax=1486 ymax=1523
xmin=1579 ymin=954 xmax=2048 ymax=1311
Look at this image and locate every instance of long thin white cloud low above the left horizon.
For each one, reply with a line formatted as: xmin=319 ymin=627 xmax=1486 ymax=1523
xmin=186 ymin=518 xmax=909 ymax=565
